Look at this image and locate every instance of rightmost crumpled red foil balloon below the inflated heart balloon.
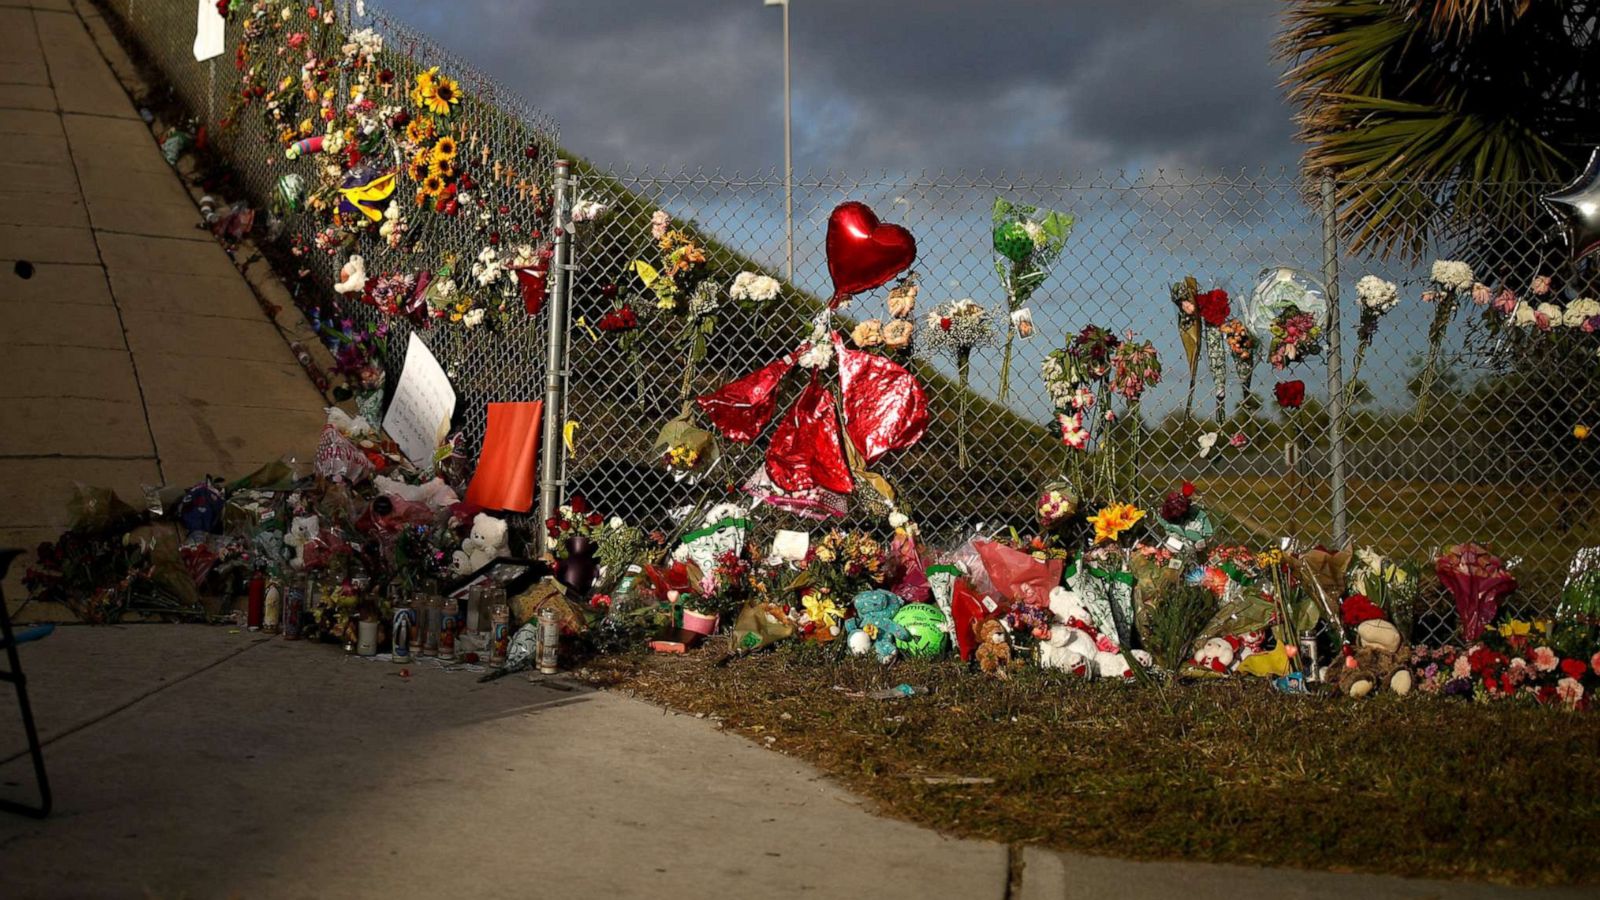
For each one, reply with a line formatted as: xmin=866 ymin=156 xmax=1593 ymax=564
xmin=834 ymin=333 xmax=928 ymax=463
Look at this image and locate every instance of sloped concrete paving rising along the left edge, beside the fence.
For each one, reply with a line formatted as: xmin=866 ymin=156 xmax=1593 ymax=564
xmin=0 ymin=0 xmax=323 ymax=618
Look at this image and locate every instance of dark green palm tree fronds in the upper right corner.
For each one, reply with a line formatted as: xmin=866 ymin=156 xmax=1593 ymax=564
xmin=1278 ymin=0 xmax=1600 ymax=262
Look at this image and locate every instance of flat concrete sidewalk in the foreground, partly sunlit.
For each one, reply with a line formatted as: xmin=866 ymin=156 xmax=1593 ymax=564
xmin=0 ymin=625 xmax=1594 ymax=900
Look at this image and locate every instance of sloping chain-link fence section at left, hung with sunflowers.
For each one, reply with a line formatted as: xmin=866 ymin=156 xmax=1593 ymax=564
xmin=101 ymin=0 xmax=557 ymax=458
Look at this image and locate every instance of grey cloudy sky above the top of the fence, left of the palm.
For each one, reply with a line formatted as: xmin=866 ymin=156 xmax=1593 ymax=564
xmin=384 ymin=0 xmax=1296 ymax=173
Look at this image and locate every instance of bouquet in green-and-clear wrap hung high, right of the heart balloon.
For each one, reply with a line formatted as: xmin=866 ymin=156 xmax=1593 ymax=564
xmin=994 ymin=197 xmax=1075 ymax=402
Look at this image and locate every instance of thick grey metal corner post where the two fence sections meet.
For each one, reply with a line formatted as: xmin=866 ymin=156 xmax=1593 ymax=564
xmin=536 ymin=160 xmax=573 ymax=552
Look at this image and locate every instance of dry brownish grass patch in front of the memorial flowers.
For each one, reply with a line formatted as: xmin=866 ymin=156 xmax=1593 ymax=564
xmin=587 ymin=645 xmax=1600 ymax=884
